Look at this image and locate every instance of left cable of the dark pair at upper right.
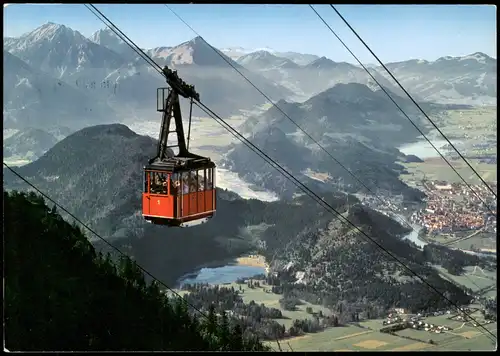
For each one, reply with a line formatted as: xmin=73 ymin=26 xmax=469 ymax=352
xmin=309 ymin=4 xmax=496 ymax=215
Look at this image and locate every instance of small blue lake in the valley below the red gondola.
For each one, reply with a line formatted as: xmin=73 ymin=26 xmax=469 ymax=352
xmin=179 ymin=265 xmax=266 ymax=285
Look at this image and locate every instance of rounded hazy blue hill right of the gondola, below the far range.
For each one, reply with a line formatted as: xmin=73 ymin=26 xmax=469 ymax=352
xmin=223 ymin=83 xmax=457 ymax=200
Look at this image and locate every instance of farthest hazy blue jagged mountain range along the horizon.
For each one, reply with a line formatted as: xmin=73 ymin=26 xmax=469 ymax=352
xmin=4 ymin=23 xmax=496 ymax=134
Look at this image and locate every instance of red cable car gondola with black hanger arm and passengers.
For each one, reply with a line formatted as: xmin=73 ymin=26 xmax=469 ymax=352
xmin=142 ymin=67 xmax=216 ymax=227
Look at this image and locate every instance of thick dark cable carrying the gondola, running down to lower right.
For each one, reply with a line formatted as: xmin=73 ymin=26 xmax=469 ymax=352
xmin=85 ymin=2 xmax=495 ymax=337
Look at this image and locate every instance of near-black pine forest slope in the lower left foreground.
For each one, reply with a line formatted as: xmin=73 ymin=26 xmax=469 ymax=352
xmin=4 ymin=191 xmax=267 ymax=351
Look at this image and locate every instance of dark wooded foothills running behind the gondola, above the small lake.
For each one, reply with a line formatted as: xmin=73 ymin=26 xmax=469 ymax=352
xmin=4 ymin=124 xmax=474 ymax=308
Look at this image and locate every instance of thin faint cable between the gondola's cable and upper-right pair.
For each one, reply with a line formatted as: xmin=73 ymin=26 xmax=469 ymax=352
xmin=164 ymin=4 xmax=413 ymax=230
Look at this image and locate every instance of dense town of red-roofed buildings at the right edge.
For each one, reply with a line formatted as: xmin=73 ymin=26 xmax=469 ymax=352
xmin=410 ymin=181 xmax=497 ymax=233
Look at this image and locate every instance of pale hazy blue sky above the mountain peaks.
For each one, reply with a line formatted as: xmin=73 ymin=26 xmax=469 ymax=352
xmin=4 ymin=4 xmax=496 ymax=63
